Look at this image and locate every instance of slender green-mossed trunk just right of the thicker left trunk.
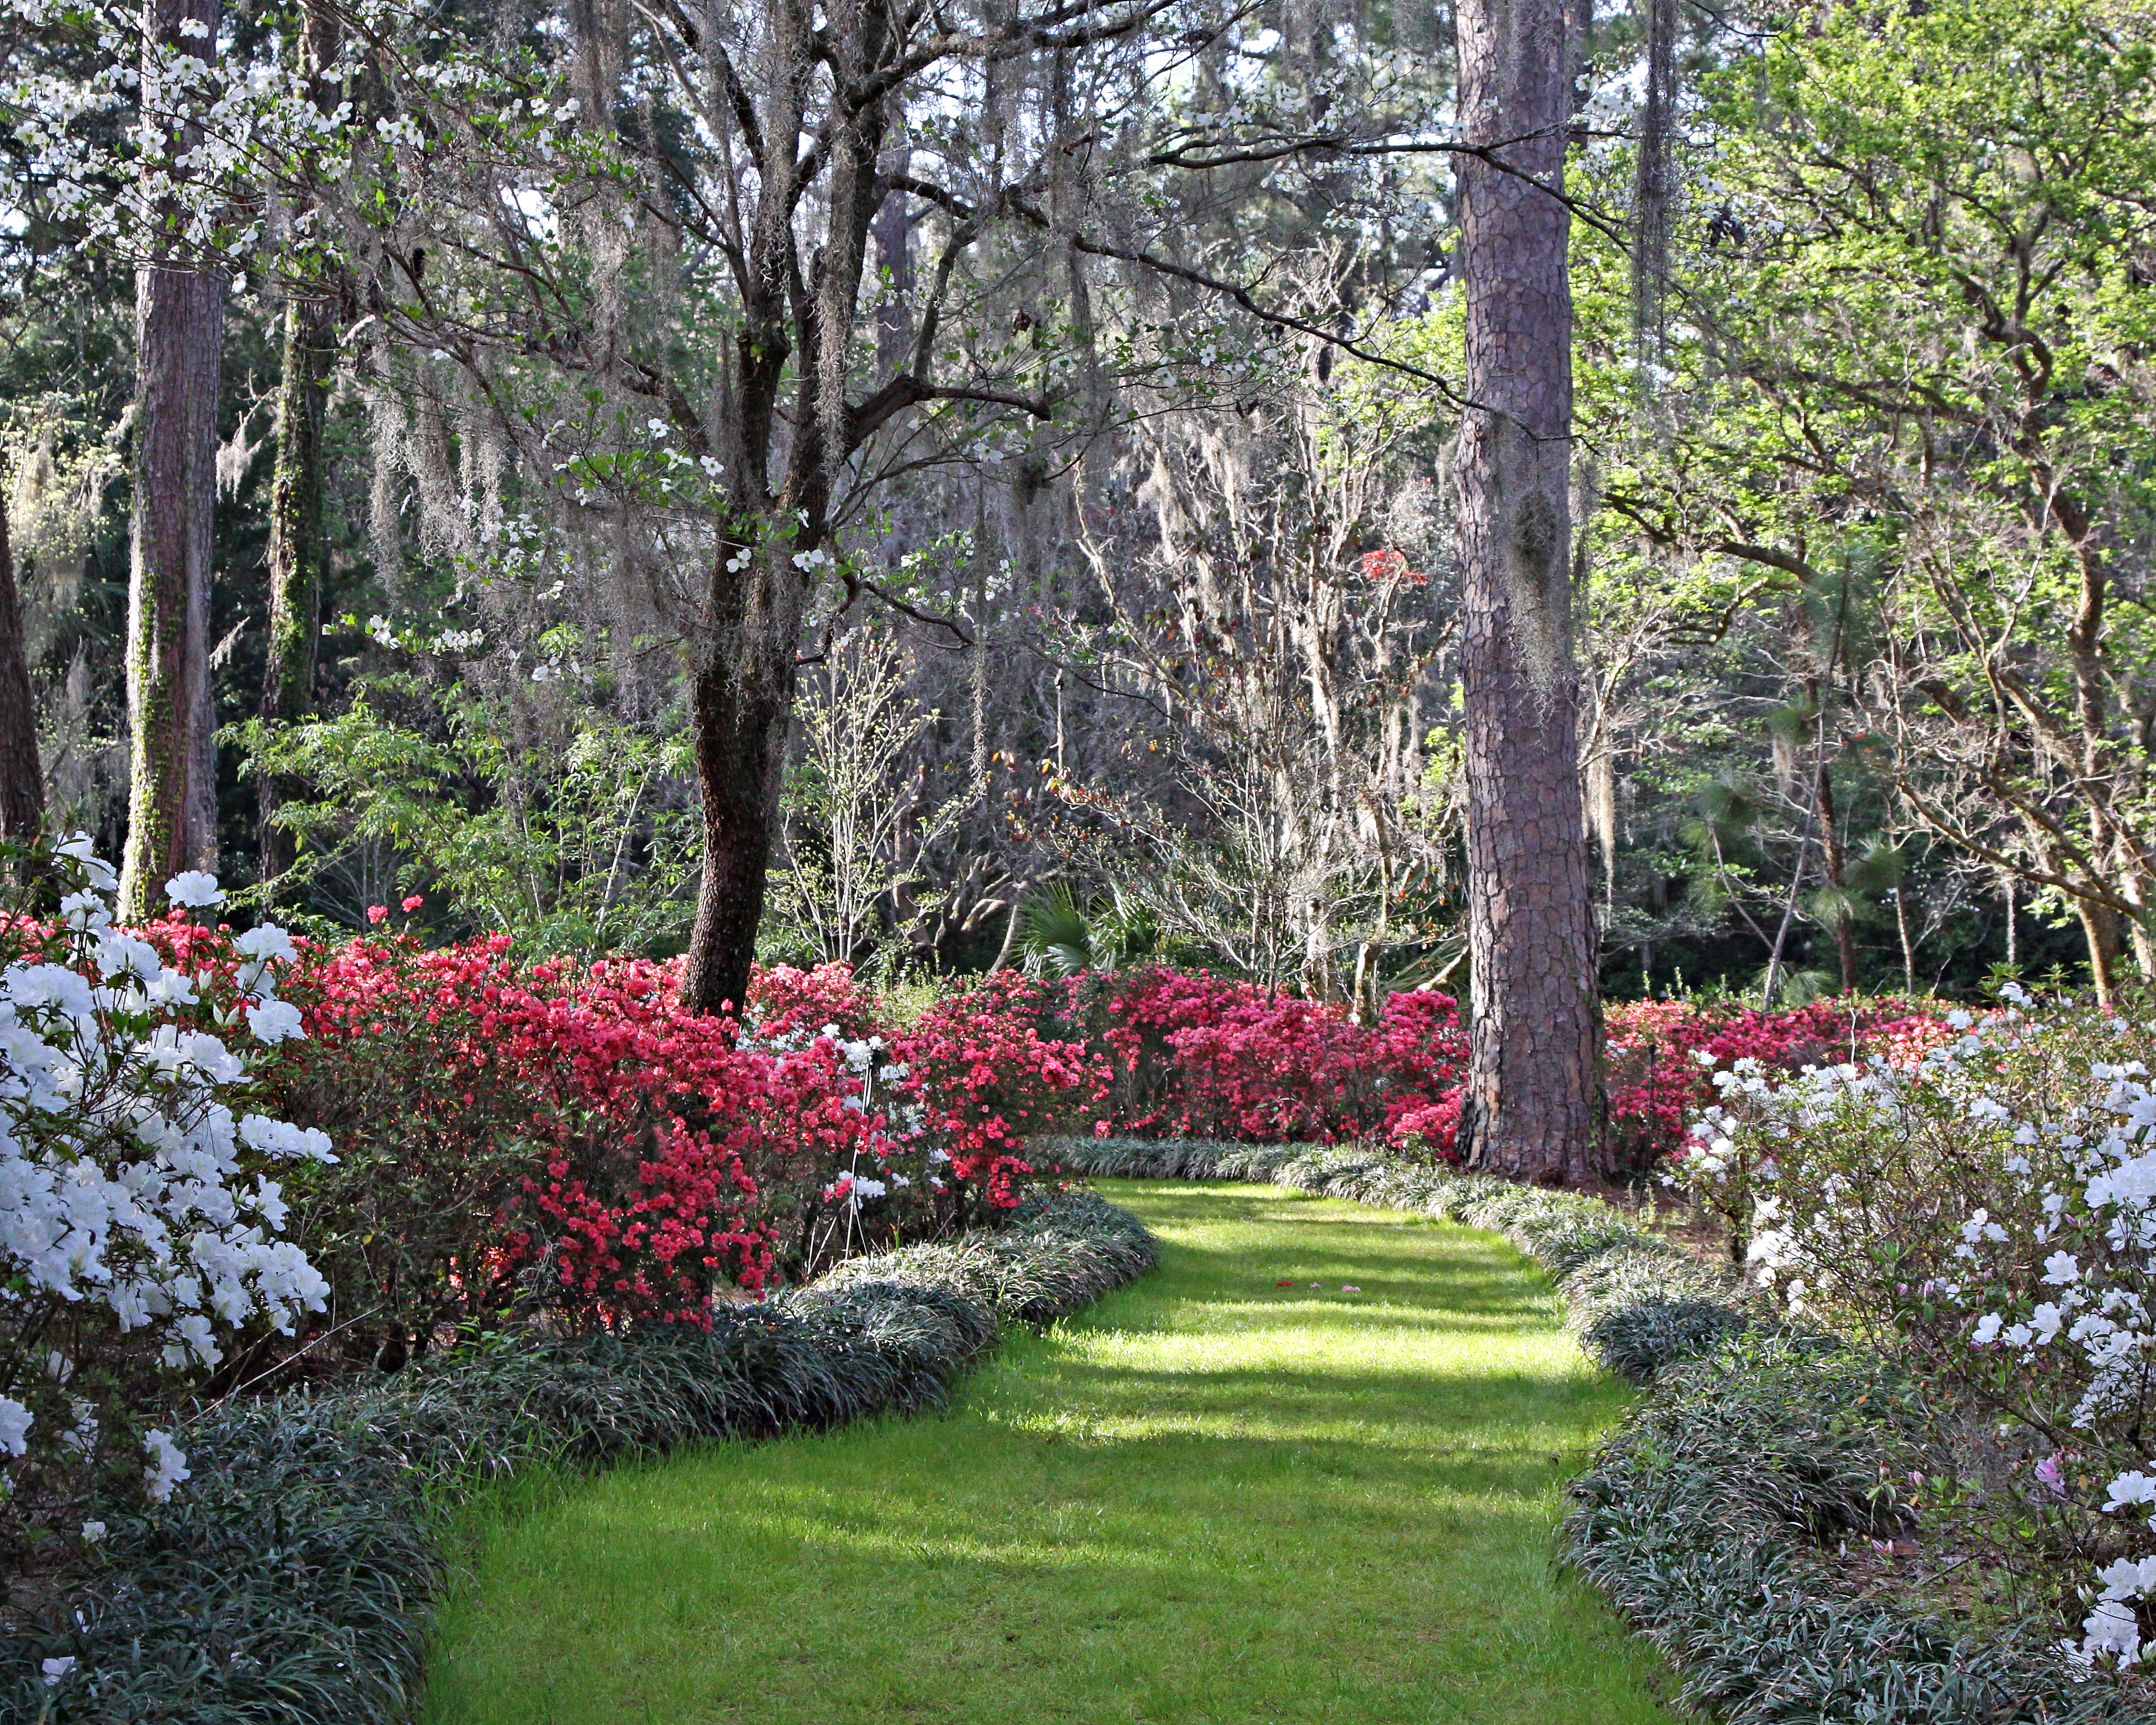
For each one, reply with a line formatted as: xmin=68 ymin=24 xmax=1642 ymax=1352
xmin=256 ymin=288 xmax=334 ymax=880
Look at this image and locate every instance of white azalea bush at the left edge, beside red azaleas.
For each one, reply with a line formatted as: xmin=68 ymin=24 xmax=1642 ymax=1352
xmin=0 ymin=837 xmax=336 ymax=1537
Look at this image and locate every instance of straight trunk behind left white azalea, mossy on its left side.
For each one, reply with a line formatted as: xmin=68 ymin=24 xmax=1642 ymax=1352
xmin=121 ymin=0 xmax=224 ymax=918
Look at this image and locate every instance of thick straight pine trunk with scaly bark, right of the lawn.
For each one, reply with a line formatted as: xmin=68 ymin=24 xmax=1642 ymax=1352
xmin=1458 ymin=0 xmax=1602 ymax=1184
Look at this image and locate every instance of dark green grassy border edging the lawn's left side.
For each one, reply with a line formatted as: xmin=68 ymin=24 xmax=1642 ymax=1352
xmin=0 ymin=1192 xmax=1155 ymax=1725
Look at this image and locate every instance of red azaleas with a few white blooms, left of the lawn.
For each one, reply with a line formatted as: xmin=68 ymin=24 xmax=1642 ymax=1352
xmin=232 ymin=934 xmax=1095 ymax=1365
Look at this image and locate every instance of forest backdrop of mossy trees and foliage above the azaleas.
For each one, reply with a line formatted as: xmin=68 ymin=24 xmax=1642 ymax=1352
xmin=0 ymin=0 xmax=2156 ymax=1030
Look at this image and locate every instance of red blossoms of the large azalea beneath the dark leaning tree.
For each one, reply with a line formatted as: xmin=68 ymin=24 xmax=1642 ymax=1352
xmin=278 ymin=936 xmax=880 ymax=1319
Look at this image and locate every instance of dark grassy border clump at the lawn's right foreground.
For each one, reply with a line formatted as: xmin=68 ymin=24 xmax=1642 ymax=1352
xmin=1565 ymin=1330 xmax=2149 ymax=1725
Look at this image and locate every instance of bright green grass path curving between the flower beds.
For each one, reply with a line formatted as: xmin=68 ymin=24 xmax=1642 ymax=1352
xmin=429 ymin=1182 xmax=1671 ymax=1725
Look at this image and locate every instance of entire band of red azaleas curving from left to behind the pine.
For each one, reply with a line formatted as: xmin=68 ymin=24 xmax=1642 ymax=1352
xmin=248 ymin=921 xmax=1945 ymax=1352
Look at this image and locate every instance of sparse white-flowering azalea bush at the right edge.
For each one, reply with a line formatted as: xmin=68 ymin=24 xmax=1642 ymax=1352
xmin=1671 ymin=987 xmax=2156 ymax=1667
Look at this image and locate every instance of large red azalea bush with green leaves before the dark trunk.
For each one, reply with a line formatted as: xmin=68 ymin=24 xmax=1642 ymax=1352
xmin=265 ymin=936 xmax=882 ymax=1348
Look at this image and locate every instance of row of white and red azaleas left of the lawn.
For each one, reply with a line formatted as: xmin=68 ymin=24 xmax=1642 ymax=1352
xmin=0 ymin=884 xmax=1102 ymax=1555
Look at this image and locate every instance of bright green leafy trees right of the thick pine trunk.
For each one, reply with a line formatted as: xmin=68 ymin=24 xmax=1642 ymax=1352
xmin=1576 ymin=0 xmax=2156 ymax=992
